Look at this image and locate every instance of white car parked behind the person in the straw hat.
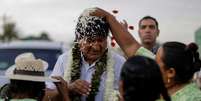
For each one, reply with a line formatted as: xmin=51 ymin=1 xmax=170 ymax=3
xmin=0 ymin=41 xmax=68 ymax=87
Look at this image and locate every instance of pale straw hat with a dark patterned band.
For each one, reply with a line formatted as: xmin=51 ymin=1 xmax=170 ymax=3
xmin=5 ymin=53 xmax=58 ymax=82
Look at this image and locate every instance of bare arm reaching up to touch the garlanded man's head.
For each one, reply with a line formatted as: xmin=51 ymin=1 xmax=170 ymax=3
xmin=91 ymin=8 xmax=140 ymax=57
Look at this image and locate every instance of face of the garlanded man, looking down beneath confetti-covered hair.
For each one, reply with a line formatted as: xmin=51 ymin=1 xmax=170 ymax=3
xmin=79 ymin=37 xmax=107 ymax=62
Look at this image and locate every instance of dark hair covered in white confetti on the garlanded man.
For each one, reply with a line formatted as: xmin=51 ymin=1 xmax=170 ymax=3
xmin=75 ymin=9 xmax=109 ymax=41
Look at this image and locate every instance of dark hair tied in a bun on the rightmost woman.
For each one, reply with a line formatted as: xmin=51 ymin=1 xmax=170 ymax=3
xmin=162 ymin=42 xmax=201 ymax=83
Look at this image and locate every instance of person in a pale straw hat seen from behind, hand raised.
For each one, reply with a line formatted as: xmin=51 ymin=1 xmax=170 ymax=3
xmin=1 ymin=53 xmax=69 ymax=101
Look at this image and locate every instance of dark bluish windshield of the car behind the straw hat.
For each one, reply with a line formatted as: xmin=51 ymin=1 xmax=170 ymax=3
xmin=0 ymin=49 xmax=62 ymax=70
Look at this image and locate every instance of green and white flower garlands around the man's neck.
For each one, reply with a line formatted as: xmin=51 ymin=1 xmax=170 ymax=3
xmin=64 ymin=43 xmax=118 ymax=101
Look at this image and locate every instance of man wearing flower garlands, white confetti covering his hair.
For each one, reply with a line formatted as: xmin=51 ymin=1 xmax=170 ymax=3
xmin=47 ymin=10 xmax=125 ymax=101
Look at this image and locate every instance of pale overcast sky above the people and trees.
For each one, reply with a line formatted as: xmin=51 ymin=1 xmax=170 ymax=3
xmin=0 ymin=0 xmax=201 ymax=43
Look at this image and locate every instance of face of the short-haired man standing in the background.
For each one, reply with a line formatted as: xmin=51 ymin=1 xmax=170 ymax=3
xmin=138 ymin=19 xmax=159 ymax=44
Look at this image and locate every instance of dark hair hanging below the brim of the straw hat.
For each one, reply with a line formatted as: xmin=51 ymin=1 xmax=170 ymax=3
xmin=8 ymin=79 xmax=45 ymax=101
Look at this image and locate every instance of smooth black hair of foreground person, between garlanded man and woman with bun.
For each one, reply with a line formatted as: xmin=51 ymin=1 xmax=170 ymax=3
xmin=121 ymin=56 xmax=170 ymax=101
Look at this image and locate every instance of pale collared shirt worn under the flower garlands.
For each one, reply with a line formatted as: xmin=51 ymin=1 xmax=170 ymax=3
xmin=46 ymin=52 xmax=125 ymax=101
